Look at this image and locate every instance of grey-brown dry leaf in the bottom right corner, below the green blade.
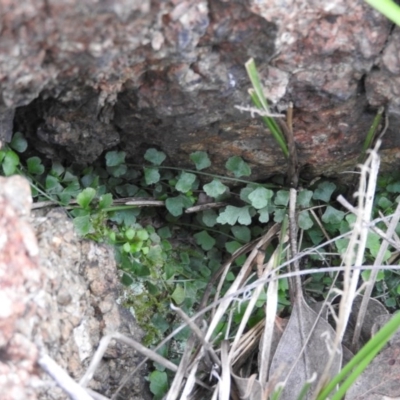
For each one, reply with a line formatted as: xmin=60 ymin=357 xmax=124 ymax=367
xmin=346 ymin=342 xmax=400 ymax=400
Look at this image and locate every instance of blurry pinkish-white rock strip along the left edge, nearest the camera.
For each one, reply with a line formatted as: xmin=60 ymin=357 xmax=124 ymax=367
xmin=0 ymin=177 xmax=40 ymax=400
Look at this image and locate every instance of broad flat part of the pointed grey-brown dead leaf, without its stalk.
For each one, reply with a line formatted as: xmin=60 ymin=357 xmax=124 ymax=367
xmin=270 ymin=296 xmax=342 ymax=400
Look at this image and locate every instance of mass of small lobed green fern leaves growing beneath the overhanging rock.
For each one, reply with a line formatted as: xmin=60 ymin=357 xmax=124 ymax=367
xmin=0 ymin=130 xmax=400 ymax=398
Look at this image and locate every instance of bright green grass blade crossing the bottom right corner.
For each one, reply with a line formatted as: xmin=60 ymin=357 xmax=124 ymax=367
xmin=317 ymin=313 xmax=400 ymax=400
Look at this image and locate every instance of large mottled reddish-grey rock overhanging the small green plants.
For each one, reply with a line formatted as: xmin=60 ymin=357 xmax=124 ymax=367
xmin=0 ymin=0 xmax=400 ymax=179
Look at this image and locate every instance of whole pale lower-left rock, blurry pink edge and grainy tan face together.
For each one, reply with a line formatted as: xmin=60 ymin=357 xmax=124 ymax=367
xmin=0 ymin=177 xmax=151 ymax=400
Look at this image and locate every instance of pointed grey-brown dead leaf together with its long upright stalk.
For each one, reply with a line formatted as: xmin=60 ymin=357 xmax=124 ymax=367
xmin=270 ymin=189 xmax=342 ymax=400
